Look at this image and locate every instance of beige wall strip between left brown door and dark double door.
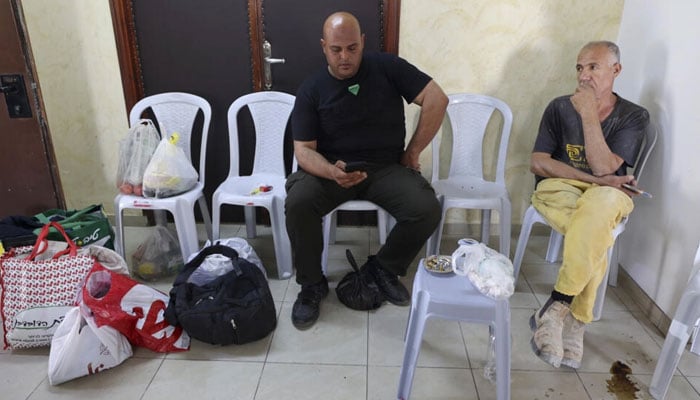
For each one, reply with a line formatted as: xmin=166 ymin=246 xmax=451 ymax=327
xmin=22 ymin=0 xmax=128 ymax=213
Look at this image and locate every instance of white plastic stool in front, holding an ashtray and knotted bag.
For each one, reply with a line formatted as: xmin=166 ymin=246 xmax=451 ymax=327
xmin=397 ymin=259 xmax=511 ymax=400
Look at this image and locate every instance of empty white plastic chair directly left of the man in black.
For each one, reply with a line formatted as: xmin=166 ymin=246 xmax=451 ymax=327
xmin=212 ymin=91 xmax=296 ymax=279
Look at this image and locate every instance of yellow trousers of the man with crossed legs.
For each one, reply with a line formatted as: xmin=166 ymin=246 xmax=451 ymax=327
xmin=532 ymin=178 xmax=634 ymax=323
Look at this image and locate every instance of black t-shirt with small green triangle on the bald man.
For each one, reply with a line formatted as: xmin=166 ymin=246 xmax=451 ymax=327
xmin=291 ymin=53 xmax=431 ymax=164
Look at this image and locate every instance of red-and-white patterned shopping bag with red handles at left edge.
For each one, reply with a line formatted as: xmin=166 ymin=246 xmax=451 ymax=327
xmin=0 ymin=222 xmax=96 ymax=348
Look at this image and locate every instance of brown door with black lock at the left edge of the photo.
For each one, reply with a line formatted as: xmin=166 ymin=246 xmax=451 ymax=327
xmin=0 ymin=0 xmax=65 ymax=218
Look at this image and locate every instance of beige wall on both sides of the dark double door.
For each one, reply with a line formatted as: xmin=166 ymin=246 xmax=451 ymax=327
xmin=22 ymin=0 xmax=623 ymax=224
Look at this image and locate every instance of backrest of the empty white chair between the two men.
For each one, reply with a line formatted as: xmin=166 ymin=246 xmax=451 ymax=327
xmin=432 ymin=93 xmax=513 ymax=185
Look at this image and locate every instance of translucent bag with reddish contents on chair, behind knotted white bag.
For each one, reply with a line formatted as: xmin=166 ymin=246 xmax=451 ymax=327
xmin=117 ymin=119 xmax=160 ymax=196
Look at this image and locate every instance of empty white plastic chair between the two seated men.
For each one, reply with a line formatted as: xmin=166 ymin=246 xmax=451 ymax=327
xmin=426 ymin=93 xmax=513 ymax=256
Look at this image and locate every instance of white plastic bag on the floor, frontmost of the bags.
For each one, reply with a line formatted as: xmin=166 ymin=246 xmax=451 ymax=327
xmin=48 ymin=306 xmax=133 ymax=385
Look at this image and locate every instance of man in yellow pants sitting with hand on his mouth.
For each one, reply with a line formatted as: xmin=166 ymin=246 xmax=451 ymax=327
xmin=530 ymin=41 xmax=649 ymax=368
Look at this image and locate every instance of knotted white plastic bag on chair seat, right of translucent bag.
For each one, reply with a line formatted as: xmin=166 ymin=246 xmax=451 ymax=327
xmin=143 ymin=133 xmax=198 ymax=198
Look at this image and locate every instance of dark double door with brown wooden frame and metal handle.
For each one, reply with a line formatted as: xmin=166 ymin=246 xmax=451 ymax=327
xmin=111 ymin=0 xmax=399 ymax=225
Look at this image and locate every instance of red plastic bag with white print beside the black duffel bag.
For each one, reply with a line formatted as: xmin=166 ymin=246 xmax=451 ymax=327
xmin=83 ymin=264 xmax=190 ymax=353
